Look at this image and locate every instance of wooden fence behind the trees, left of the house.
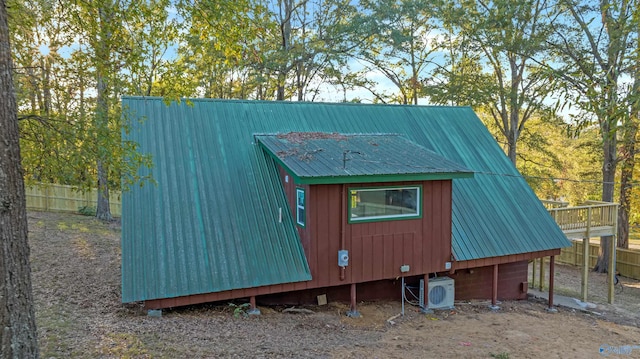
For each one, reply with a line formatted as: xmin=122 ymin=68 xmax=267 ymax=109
xmin=25 ymin=184 xmax=122 ymax=217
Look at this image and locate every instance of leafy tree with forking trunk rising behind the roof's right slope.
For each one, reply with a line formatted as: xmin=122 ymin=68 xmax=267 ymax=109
xmin=425 ymin=0 xmax=553 ymax=164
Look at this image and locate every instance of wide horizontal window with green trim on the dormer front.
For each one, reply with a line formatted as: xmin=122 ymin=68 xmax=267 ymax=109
xmin=349 ymin=186 xmax=421 ymax=223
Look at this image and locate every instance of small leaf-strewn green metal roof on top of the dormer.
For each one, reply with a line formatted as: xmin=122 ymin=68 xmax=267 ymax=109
xmin=255 ymin=132 xmax=473 ymax=184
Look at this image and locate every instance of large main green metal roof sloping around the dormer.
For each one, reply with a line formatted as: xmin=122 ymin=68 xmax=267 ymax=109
xmin=122 ymin=97 xmax=570 ymax=302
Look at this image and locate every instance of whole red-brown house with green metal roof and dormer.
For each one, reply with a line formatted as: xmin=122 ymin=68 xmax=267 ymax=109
xmin=122 ymin=97 xmax=570 ymax=308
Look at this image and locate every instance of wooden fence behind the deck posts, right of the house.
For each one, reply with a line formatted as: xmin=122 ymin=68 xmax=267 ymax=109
xmin=556 ymin=240 xmax=640 ymax=279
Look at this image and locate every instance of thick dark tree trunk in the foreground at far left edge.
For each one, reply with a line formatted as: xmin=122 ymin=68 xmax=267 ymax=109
xmin=0 ymin=0 xmax=39 ymax=358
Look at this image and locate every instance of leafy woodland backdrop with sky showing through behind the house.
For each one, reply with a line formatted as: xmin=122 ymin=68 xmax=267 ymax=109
xmin=8 ymin=0 xmax=640 ymax=229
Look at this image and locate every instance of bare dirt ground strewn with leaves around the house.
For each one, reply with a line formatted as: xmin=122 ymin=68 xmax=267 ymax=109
xmin=28 ymin=212 xmax=640 ymax=359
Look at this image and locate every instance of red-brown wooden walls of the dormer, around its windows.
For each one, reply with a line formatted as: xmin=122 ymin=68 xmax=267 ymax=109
xmin=280 ymin=170 xmax=452 ymax=288
